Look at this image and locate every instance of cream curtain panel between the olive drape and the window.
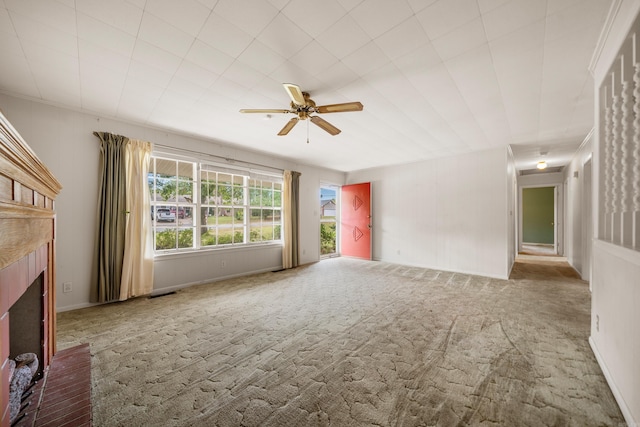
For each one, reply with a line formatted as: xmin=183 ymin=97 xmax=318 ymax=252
xmin=120 ymin=139 xmax=153 ymax=301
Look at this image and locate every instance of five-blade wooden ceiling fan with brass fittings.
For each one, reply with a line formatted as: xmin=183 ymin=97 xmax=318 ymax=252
xmin=240 ymin=83 xmax=364 ymax=136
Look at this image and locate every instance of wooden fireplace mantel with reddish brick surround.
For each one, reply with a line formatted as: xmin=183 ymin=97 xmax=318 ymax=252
xmin=0 ymin=112 xmax=62 ymax=427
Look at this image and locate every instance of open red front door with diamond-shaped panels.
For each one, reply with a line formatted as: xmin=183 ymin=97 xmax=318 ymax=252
xmin=340 ymin=182 xmax=371 ymax=260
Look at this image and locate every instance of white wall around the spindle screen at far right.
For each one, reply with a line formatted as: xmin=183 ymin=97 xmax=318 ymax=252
xmin=589 ymin=0 xmax=640 ymax=425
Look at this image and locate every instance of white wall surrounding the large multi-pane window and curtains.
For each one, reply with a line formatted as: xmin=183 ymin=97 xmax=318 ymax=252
xmin=0 ymin=94 xmax=345 ymax=311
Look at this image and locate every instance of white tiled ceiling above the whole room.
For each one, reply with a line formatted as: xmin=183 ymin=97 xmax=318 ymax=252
xmin=0 ymin=0 xmax=611 ymax=171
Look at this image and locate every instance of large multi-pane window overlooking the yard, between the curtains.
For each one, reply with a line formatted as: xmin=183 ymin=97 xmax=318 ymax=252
xmin=149 ymin=156 xmax=282 ymax=252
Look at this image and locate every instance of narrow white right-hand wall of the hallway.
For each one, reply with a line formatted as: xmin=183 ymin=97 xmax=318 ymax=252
xmin=564 ymin=134 xmax=593 ymax=280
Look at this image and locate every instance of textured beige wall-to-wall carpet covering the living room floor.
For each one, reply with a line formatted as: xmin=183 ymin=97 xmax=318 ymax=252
xmin=58 ymin=257 xmax=624 ymax=426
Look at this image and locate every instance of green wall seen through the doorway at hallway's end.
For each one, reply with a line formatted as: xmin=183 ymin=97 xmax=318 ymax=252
xmin=522 ymin=187 xmax=555 ymax=244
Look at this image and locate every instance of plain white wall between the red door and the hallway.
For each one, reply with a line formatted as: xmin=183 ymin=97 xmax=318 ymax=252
xmin=347 ymin=148 xmax=511 ymax=278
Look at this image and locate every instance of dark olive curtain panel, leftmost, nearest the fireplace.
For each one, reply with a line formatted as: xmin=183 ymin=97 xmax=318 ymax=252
xmin=91 ymin=132 xmax=129 ymax=302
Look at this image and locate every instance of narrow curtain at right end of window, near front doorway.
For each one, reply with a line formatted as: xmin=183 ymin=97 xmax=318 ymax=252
xmin=282 ymin=171 xmax=300 ymax=268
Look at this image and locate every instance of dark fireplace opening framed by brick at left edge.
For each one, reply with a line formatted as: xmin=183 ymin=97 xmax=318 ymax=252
xmin=9 ymin=272 xmax=44 ymax=375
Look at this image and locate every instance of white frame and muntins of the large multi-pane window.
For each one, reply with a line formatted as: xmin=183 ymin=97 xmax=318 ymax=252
xmin=147 ymin=151 xmax=284 ymax=256
